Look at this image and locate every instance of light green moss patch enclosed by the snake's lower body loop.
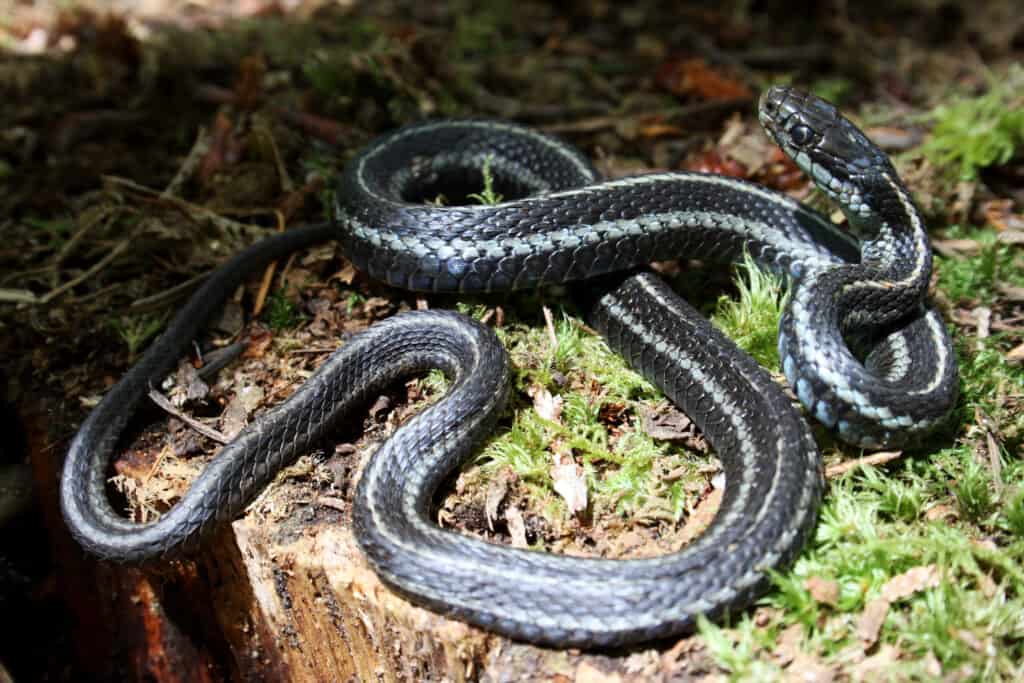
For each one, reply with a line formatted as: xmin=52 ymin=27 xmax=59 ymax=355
xmin=477 ymin=313 xmax=706 ymax=523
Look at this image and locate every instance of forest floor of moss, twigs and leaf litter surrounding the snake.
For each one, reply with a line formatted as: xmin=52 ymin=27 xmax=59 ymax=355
xmin=0 ymin=0 xmax=1024 ymax=681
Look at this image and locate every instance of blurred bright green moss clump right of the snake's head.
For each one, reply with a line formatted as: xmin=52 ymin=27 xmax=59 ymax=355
xmin=923 ymin=68 xmax=1024 ymax=180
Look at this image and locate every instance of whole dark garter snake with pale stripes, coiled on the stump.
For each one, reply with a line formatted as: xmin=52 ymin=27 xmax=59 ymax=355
xmin=61 ymin=87 xmax=956 ymax=647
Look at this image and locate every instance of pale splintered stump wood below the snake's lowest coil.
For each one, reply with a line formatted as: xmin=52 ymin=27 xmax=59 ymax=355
xmin=213 ymin=501 xmax=709 ymax=682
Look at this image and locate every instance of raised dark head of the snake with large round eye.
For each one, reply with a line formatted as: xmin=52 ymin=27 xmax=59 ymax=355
xmin=758 ymin=85 xmax=896 ymax=216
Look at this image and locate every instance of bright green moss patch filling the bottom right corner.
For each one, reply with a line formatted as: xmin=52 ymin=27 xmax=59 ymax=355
xmin=700 ymin=447 xmax=1024 ymax=680
